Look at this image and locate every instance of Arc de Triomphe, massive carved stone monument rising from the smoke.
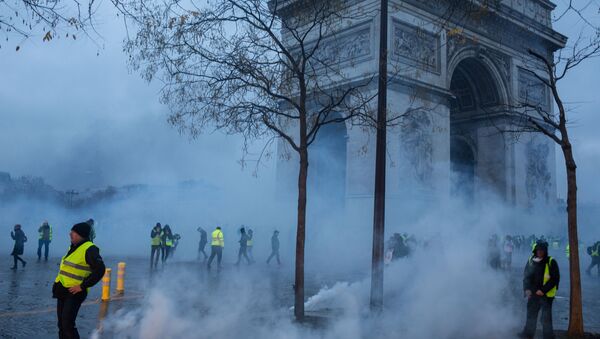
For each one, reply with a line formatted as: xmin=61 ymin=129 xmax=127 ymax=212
xmin=277 ymin=0 xmax=566 ymax=224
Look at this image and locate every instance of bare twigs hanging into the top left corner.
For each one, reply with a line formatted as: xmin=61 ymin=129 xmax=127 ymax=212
xmin=0 ymin=0 xmax=97 ymax=51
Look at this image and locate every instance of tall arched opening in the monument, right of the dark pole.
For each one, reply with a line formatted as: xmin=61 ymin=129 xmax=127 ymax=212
xmin=450 ymin=53 xmax=507 ymax=201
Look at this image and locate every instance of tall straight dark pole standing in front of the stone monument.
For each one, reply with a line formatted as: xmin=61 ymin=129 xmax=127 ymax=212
xmin=371 ymin=0 xmax=388 ymax=311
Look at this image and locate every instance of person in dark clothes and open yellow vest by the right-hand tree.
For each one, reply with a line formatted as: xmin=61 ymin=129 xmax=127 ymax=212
xmin=520 ymin=240 xmax=560 ymax=339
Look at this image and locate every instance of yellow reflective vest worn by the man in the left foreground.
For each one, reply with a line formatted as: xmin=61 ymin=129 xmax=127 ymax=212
xmin=54 ymin=241 xmax=94 ymax=288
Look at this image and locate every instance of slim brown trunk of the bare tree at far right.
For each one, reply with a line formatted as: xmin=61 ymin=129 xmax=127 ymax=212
xmin=562 ymin=141 xmax=584 ymax=337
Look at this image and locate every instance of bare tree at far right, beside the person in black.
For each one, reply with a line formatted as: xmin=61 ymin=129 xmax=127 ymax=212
xmin=510 ymin=19 xmax=600 ymax=337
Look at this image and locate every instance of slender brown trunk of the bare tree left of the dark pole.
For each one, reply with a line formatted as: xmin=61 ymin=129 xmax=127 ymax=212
xmin=294 ymin=126 xmax=308 ymax=321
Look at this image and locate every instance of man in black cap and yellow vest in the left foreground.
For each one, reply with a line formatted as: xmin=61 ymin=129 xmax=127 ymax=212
xmin=52 ymin=222 xmax=106 ymax=339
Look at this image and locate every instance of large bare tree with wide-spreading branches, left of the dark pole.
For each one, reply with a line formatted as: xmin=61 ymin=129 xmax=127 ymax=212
xmin=114 ymin=0 xmax=384 ymax=320
